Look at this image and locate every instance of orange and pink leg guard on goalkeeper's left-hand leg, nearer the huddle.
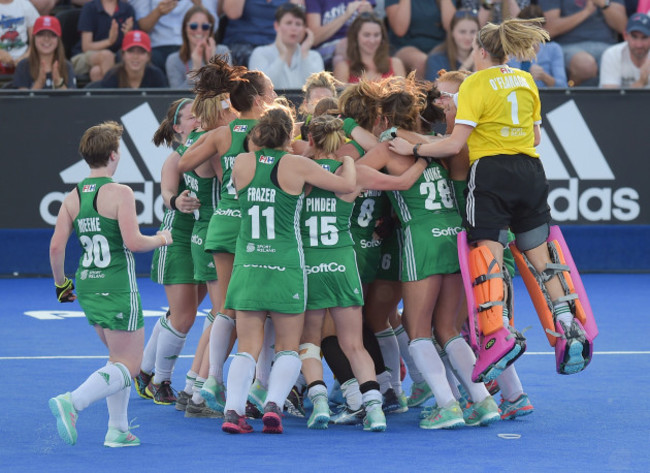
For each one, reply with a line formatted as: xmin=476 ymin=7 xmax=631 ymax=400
xmin=458 ymin=232 xmax=526 ymax=382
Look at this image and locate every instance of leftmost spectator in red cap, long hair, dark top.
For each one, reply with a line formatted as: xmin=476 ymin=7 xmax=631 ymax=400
xmin=12 ymin=16 xmax=77 ymax=89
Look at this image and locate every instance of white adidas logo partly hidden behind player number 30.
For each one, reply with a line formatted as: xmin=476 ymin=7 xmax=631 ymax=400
xmin=39 ymin=102 xmax=171 ymax=225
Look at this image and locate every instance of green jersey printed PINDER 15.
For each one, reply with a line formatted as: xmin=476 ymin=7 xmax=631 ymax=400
xmin=301 ymin=159 xmax=354 ymax=249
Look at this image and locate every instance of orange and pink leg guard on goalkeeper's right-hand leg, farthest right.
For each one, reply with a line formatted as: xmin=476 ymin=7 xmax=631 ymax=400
xmin=511 ymin=225 xmax=598 ymax=374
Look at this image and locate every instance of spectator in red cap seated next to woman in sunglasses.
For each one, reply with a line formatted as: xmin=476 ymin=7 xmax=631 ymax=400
xmin=100 ymin=31 xmax=167 ymax=89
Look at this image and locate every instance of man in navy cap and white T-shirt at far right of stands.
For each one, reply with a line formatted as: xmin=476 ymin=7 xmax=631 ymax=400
xmin=600 ymin=13 xmax=650 ymax=89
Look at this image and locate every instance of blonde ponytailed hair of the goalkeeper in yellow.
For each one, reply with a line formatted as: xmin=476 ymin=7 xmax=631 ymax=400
xmin=476 ymin=18 xmax=551 ymax=63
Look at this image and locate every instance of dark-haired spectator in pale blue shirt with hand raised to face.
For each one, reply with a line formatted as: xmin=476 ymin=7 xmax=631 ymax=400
xmin=249 ymin=3 xmax=325 ymax=89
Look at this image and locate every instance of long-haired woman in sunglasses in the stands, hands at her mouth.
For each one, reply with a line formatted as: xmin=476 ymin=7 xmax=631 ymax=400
xmin=165 ymin=5 xmax=230 ymax=89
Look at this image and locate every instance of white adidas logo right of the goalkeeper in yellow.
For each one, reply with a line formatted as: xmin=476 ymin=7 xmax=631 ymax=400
xmin=537 ymin=100 xmax=641 ymax=222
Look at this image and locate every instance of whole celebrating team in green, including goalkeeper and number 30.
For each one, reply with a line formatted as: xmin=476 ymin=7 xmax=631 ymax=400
xmin=45 ymin=20 xmax=597 ymax=447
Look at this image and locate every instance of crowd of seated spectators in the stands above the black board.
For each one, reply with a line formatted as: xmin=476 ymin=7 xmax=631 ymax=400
xmin=0 ymin=0 xmax=650 ymax=90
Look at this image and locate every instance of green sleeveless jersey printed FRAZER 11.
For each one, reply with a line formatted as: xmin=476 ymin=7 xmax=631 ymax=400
xmin=234 ymin=149 xmax=304 ymax=268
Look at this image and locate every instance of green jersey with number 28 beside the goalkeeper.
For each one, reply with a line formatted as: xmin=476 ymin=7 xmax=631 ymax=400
xmin=389 ymin=161 xmax=457 ymax=226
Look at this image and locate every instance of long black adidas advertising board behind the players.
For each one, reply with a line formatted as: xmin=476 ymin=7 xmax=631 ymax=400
xmin=0 ymin=89 xmax=650 ymax=229
